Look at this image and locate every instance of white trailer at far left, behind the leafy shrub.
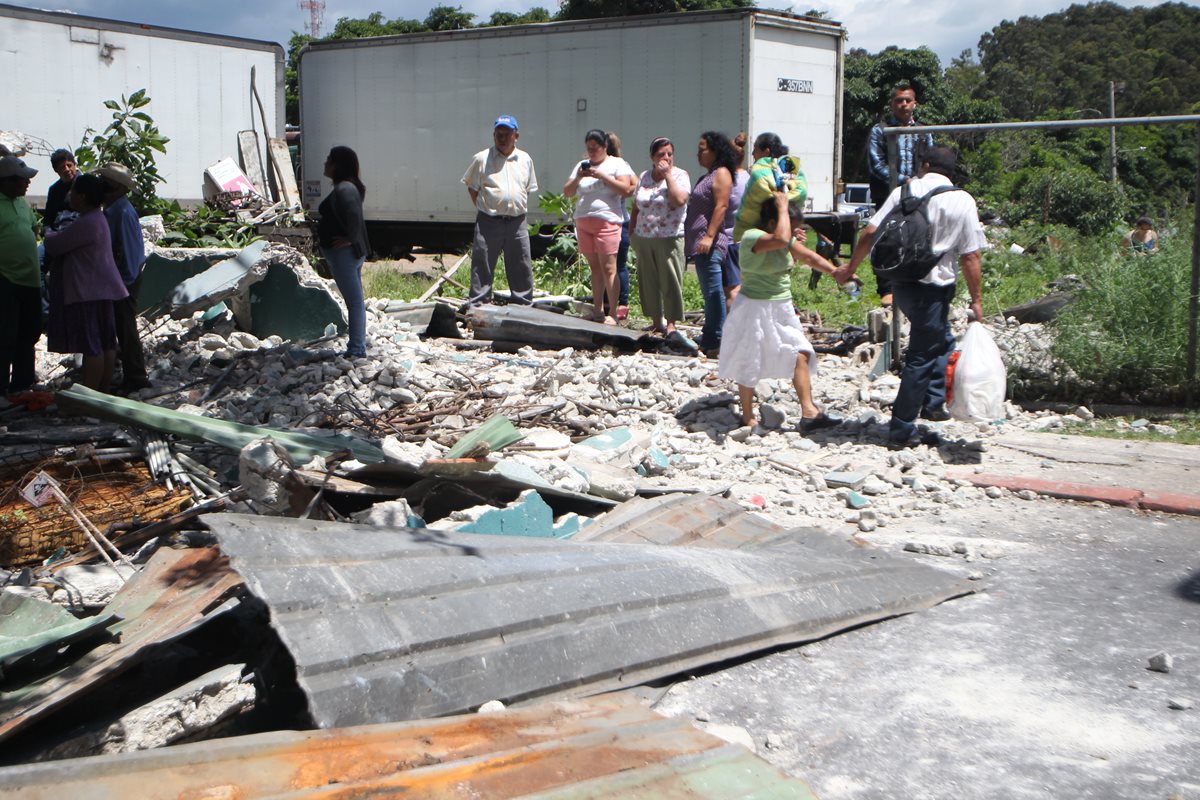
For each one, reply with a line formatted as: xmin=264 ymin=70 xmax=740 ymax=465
xmin=0 ymin=5 xmax=284 ymax=204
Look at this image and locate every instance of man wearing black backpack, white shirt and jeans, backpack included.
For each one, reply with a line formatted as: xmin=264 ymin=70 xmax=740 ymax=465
xmin=834 ymin=148 xmax=984 ymax=447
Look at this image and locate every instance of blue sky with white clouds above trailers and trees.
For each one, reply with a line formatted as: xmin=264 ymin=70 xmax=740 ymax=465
xmin=6 ymin=0 xmax=1200 ymax=65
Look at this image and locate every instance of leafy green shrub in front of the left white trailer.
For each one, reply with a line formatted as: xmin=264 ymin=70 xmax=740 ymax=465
xmin=76 ymin=89 xmax=170 ymax=213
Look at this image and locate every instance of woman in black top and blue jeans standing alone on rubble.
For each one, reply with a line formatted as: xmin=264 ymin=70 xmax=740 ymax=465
xmin=317 ymin=146 xmax=370 ymax=356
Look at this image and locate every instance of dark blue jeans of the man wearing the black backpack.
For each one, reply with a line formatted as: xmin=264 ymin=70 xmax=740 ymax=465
xmin=888 ymin=283 xmax=955 ymax=441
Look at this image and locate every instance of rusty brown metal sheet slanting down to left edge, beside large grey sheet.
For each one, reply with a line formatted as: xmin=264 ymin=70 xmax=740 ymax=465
xmin=0 ymin=547 xmax=241 ymax=740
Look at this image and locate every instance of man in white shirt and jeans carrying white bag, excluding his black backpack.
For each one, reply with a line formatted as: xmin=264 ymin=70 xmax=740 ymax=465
xmin=834 ymin=148 xmax=985 ymax=447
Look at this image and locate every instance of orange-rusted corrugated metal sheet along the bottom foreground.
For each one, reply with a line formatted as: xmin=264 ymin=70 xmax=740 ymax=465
xmin=0 ymin=696 xmax=815 ymax=800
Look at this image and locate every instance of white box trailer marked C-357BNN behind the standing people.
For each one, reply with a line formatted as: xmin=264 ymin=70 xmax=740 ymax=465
xmin=299 ymin=8 xmax=845 ymax=251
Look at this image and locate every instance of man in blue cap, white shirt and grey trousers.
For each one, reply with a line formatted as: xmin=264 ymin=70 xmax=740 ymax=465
xmin=462 ymin=114 xmax=538 ymax=306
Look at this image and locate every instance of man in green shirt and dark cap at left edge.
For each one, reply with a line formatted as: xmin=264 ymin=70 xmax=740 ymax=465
xmin=0 ymin=156 xmax=42 ymax=396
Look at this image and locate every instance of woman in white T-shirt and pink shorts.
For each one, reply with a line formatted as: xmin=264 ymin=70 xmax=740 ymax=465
xmin=563 ymin=131 xmax=637 ymax=325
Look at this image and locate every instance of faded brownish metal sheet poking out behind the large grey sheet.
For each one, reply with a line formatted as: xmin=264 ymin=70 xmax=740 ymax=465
xmin=571 ymin=494 xmax=835 ymax=552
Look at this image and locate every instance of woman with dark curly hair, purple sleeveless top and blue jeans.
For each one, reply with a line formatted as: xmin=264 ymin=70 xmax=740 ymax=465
xmin=684 ymin=131 xmax=738 ymax=357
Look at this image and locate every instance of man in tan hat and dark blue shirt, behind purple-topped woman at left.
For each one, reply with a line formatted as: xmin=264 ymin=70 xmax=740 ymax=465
xmin=96 ymin=162 xmax=150 ymax=393
